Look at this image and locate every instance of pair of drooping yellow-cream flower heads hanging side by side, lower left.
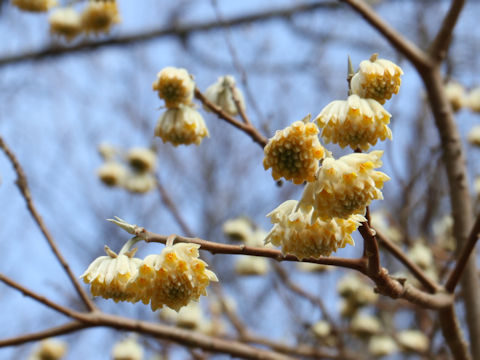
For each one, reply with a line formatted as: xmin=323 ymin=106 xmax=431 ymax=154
xmin=81 ymin=243 xmax=218 ymax=311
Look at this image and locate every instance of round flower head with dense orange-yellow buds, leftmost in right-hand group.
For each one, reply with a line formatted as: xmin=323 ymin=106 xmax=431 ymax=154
xmin=263 ymin=115 xmax=325 ymax=184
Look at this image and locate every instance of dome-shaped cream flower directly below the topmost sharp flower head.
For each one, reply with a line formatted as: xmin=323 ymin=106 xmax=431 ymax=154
xmin=315 ymin=95 xmax=392 ymax=151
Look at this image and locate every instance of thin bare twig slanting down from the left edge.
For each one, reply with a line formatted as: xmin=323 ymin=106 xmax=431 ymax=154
xmin=0 ymin=136 xmax=96 ymax=311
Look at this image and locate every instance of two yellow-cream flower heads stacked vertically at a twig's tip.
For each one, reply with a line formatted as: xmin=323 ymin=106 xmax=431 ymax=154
xmin=153 ymin=67 xmax=209 ymax=146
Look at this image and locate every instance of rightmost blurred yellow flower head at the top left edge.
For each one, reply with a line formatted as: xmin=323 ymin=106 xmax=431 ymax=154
xmin=81 ymin=0 xmax=120 ymax=34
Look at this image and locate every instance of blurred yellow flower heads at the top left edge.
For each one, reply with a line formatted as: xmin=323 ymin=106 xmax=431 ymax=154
xmin=12 ymin=0 xmax=120 ymax=41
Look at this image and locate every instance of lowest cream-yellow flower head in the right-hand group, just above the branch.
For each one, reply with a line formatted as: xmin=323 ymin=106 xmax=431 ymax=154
xmin=265 ymin=200 xmax=366 ymax=260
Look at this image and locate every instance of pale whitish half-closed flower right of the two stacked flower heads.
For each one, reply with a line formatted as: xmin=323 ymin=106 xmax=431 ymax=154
xmin=204 ymin=75 xmax=245 ymax=116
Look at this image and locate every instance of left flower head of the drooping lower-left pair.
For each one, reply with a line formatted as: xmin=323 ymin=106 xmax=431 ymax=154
xmin=80 ymin=245 xmax=142 ymax=302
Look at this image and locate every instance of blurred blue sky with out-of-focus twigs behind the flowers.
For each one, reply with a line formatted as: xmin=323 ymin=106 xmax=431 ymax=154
xmin=0 ymin=0 xmax=480 ymax=359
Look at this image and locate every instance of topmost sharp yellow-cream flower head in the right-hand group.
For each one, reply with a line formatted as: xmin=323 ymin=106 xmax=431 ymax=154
xmin=351 ymin=54 xmax=403 ymax=104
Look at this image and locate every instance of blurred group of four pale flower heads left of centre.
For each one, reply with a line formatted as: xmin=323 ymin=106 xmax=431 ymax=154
xmin=98 ymin=144 xmax=157 ymax=193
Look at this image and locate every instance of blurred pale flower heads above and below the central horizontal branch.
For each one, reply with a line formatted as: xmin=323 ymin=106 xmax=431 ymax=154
xmin=223 ymin=217 xmax=270 ymax=276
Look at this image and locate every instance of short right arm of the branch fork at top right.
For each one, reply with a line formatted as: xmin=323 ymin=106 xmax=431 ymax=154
xmin=430 ymin=0 xmax=465 ymax=63
